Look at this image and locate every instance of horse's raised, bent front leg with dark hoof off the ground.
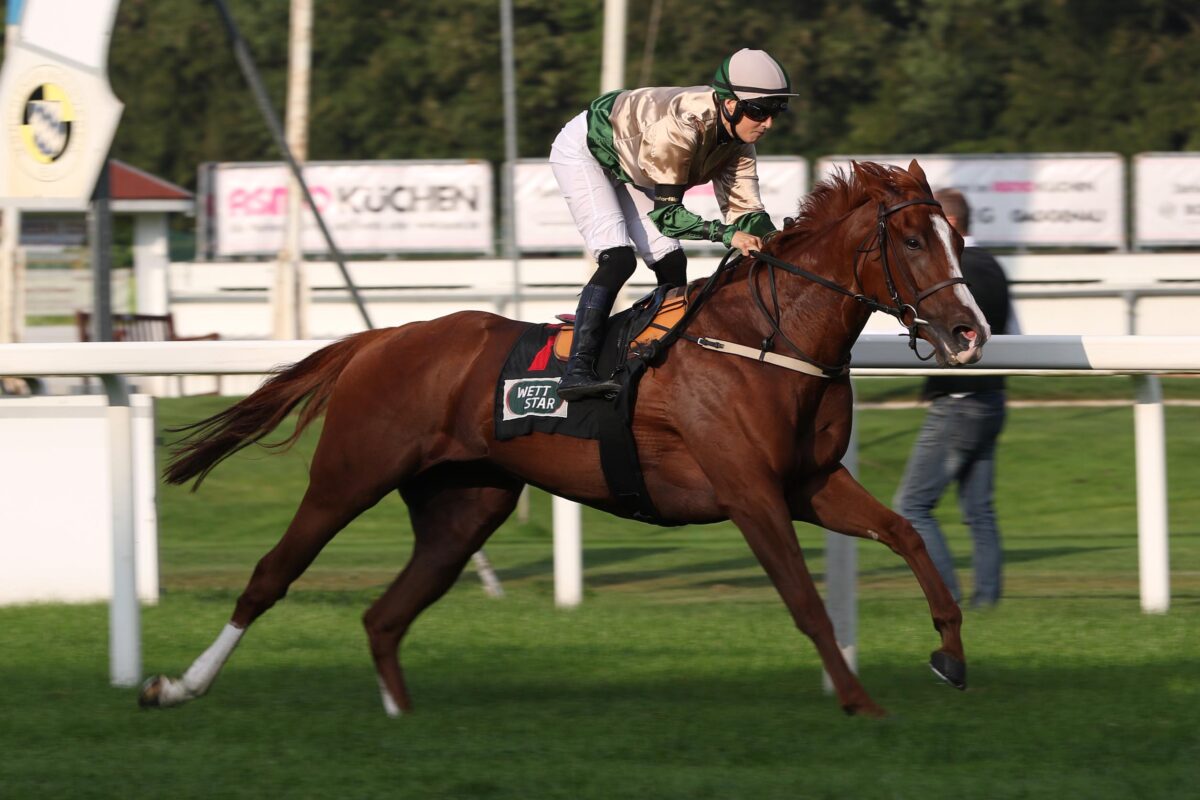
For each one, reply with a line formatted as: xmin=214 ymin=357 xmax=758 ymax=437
xmin=788 ymin=465 xmax=967 ymax=688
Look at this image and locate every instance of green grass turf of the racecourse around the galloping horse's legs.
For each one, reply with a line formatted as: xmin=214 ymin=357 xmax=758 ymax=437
xmin=0 ymin=383 xmax=1200 ymax=798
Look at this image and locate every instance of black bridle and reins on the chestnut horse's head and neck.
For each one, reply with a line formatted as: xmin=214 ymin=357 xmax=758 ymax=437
xmin=749 ymin=197 xmax=966 ymax=373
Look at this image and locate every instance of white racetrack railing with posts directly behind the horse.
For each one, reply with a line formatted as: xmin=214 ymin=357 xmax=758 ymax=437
xmin=0 ymin=335 xmax=1200 ymax=686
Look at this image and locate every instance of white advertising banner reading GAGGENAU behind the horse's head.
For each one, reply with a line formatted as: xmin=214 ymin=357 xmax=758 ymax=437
xmin=816 ymin=154 xmax=1126 ymax=249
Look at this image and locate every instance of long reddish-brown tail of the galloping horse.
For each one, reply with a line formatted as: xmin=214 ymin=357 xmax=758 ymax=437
xmin=163 ymin=330 xmax=384 ymax=491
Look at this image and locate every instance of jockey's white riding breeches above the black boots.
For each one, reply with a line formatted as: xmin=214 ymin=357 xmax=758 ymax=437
xmin=550 ymin=112 xmax=679 ymax=265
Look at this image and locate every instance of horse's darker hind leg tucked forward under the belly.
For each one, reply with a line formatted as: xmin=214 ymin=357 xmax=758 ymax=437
xmin=362 ymin=464 xmax=522 ymax=716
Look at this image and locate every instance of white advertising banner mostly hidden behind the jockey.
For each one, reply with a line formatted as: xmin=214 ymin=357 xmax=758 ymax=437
xmin=512 ymin=156 xmax=809 ymax=252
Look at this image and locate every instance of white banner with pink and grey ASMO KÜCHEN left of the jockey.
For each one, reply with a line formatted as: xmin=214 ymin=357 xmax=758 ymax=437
xmin=206 ymin=161 xmax=493 ymax=258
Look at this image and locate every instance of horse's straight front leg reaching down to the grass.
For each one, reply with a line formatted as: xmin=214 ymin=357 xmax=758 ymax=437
xmin=725 ymin=489 xmax=886 ymax=716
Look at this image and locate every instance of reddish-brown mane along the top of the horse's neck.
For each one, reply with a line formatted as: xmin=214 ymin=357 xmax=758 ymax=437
xmin=779 ymin=161 xmax=930 ymax=247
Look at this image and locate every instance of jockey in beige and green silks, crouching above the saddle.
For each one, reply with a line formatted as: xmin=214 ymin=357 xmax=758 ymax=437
xmin=550 ymin=49 xmax=796 ymax=401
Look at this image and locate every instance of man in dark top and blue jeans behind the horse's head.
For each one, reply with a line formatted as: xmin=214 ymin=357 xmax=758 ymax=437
xmin=894 ymin=190 xmax=1020 ymax=608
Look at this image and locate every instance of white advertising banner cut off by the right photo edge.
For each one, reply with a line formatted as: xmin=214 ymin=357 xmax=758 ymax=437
xmin=1133 ymin=152 xmax=1200 ymax=247
